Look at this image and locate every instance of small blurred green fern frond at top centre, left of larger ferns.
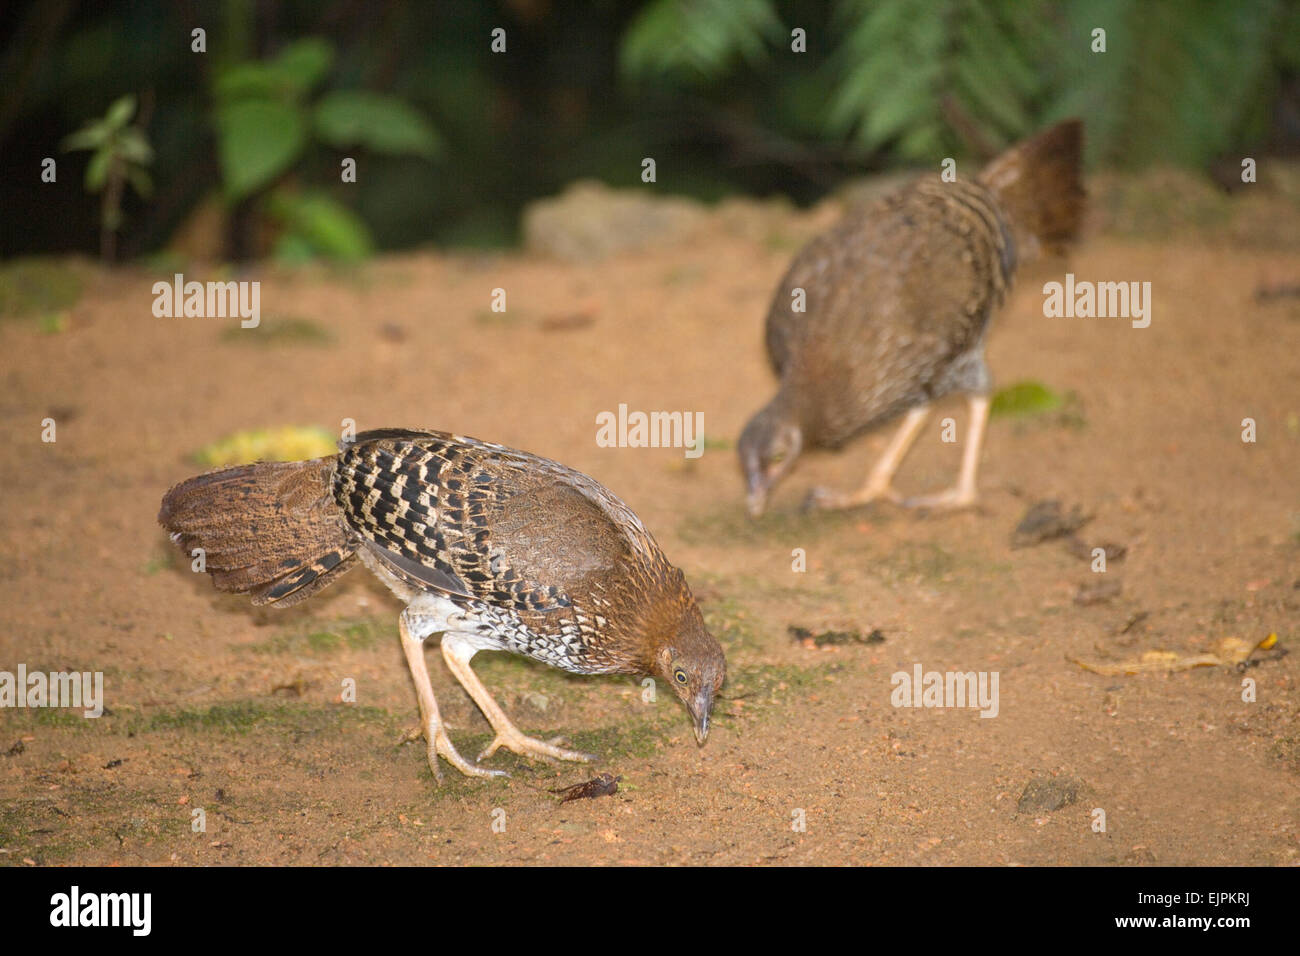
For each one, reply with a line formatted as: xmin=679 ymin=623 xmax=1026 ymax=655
xmin=619 ymin=0 xmax=783 ymax=82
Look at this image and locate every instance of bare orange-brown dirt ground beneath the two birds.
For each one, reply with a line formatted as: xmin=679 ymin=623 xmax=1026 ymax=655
xmin=0 ymin=178 xmax=1300 ymax=865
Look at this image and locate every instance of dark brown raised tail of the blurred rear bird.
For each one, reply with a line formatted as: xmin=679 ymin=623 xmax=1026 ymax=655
xmin=979 ymin=120 xmax=1084 ymax=254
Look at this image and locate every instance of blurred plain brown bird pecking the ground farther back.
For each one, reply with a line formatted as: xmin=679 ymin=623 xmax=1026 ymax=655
xmin=738 ymin=120 xmax=1083 ymax=516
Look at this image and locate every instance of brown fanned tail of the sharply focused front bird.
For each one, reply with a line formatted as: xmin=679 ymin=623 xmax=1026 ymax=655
xmin=159 ymin=458 xmax=356 ymax=606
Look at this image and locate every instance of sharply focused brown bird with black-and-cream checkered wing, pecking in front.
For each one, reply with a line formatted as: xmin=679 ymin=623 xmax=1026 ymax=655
xmin=159 ymin=429 xmax=727 ymax=779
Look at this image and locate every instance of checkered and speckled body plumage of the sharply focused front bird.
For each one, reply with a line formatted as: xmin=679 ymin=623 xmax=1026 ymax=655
xmin=333 ymin=432 xmax=694 ymax=674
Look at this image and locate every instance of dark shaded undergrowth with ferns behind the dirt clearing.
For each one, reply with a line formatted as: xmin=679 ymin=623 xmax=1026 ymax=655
xmin=0 ymin=0 xmax=1300 ymax=258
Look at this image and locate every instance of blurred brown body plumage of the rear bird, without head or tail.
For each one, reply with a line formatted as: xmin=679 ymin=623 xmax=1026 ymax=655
xmin=767 ymin=177 xmax=1015 ymax=449
